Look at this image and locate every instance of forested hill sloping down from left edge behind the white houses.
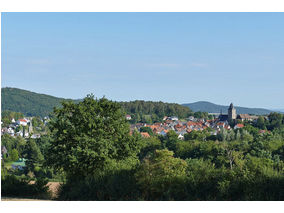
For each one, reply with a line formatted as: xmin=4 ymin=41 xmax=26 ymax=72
xmin=1 ymin=87 xmax=77 ymax=117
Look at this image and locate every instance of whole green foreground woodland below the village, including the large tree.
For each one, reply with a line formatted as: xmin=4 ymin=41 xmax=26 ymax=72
xmin=1 ymin=96 xmax=284 ymax=201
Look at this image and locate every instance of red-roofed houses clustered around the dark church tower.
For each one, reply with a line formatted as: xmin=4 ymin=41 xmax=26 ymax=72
xmin=130 ymin=104 xmax=258 ymax=139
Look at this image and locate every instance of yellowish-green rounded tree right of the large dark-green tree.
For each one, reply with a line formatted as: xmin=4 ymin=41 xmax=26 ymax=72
xmin=135 ymin=149 xmax=186 ymax=200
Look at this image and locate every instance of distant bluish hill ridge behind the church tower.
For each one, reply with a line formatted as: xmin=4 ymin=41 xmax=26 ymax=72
xmin=183 ymin=101 xmax=272 ymax=115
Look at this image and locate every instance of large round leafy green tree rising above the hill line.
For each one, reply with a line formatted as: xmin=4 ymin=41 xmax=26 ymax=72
xmin=47 ymin=95 xmax=138 ymax=180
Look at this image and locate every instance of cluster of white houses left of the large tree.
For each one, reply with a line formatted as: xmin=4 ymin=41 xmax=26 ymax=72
xmin=1 ymin=117 xmax=49 ymax=138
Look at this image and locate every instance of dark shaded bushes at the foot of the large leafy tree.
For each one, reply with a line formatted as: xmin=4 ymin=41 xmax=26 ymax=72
xmin=58 ymin=170 xmax=141 ymax=201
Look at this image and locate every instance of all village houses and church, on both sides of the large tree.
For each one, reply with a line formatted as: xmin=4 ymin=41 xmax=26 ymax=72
xmin=1 ymin=104 xmax=258 ymax=140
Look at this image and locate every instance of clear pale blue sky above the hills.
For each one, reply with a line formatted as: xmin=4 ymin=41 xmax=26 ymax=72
xmin=1 ymin=13 xmax=284 ymax=108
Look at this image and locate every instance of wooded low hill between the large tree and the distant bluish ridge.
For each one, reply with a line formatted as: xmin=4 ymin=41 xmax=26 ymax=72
xmin=120 ymin=101 xmax=192 ymax=123
